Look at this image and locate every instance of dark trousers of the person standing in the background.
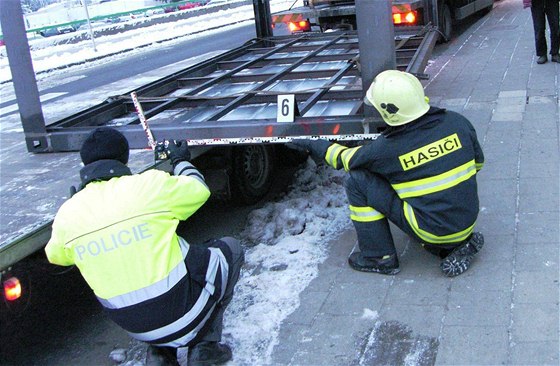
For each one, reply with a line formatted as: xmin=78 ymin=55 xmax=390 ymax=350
xmin=531 ymin=0 xmax=560 ymax=56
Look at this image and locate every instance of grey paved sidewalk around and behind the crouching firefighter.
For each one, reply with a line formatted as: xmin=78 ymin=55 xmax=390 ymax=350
xmin=273 ymin=0 xmax=560 ymax=365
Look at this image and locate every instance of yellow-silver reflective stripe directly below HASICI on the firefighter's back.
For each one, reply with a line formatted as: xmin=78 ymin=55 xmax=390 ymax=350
xmin=392 ymin=160 xmax=476 ymax=199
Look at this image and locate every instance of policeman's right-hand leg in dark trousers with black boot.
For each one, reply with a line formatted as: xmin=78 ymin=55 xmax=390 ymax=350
xmin=188 ymin=237 xmax=245 ymax=366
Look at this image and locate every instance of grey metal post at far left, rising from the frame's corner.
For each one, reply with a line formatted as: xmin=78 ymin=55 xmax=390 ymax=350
xmin=0 ymin=1 xmax=49 ymax=152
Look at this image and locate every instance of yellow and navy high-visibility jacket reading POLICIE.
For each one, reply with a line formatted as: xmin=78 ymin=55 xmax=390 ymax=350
xmin=45 ymin=160 xmax=228 ymax=346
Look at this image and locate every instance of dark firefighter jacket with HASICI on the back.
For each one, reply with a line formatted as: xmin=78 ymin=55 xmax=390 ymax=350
xmin=325 ymin=107 xmax=484 ymax=244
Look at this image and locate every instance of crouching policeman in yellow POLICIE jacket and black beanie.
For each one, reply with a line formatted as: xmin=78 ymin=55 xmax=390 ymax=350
xmin=45 ymin=127 xmax=244 ymax=365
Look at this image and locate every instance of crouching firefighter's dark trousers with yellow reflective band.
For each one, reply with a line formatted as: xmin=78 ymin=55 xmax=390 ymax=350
xmin=345 ymin=170 xmax=459 ymax=257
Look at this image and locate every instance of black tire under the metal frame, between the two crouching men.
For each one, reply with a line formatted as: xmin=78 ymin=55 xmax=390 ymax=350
xmin=231 ymin=145 xmax=274 ymax=204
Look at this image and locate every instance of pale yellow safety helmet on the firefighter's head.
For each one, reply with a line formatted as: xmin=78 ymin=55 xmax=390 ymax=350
xmin=364 ymin=70 xmax=430 ymax=126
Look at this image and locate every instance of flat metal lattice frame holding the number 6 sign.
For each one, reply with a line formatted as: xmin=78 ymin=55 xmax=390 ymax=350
xmin=28 ymin=28 xmax=437 ymax=152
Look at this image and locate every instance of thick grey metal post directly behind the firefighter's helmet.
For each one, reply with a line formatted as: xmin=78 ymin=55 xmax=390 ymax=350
xmin=356 ymin=0 xmax=397 ymax=116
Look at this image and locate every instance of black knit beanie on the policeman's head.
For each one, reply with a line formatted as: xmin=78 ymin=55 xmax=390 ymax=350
xmin=80 ymin=127 xmax=128 ymax=165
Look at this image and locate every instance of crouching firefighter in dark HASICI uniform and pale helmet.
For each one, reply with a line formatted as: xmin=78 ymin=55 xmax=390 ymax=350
xmin=294 ymin=70 xmax=484 ymax=277
